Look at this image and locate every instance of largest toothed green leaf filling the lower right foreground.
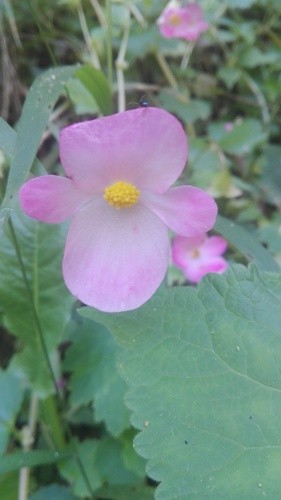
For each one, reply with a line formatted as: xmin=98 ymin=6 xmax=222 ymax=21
xmin=80 ymin=266 xmax=281 ymax=500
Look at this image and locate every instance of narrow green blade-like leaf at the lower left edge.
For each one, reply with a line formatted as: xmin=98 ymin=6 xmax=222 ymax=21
xmin=0 ymin=450 xmax=71 ymax=474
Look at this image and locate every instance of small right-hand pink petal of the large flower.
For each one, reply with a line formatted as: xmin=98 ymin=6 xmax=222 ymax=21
xmin=141 ymin=186 xmax=217 ymax=236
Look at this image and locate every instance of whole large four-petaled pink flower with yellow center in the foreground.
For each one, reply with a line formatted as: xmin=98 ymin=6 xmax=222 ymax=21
xmin=20 ymin=108 xmax=217 ymax=312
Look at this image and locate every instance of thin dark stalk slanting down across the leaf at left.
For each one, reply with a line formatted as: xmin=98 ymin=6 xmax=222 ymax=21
xmin=8 ymin=219 xmax=94 ymax=498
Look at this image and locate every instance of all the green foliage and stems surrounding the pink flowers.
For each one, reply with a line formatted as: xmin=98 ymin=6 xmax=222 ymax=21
xmin=0 ymin=0 xmax=281 ymax=500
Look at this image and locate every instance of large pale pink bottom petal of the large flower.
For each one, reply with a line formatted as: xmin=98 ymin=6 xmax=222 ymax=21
xmin=63 ymin=197 xmax=169 ymax=312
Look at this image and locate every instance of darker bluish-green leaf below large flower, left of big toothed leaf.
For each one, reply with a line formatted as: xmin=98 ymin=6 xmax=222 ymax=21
xmin=64 ymin=320 xmax=130 ymax=436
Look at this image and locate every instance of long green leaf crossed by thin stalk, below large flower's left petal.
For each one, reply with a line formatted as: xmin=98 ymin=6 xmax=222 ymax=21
xmin=0 ymin=205 xmax=74 ymax=396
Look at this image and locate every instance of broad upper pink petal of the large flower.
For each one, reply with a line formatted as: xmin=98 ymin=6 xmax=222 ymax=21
xmin=60 ymin=107 xmax=187 ymax=193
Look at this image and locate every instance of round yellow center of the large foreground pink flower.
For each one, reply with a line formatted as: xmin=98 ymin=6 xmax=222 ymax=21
xmin=103 ymin=181 xmax=140 ymax=209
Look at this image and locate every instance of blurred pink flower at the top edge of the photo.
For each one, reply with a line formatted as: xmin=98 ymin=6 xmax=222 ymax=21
xmin=157 ymin=2 xmax=208 ymax=42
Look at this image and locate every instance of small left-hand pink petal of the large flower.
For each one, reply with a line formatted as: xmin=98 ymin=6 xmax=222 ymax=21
xmin=19 ymin=175 xmax=91 ymax=224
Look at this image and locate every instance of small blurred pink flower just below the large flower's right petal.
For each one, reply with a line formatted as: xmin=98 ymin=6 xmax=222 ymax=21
xmin=172 ymin=234 xmax=228 ymax=283
